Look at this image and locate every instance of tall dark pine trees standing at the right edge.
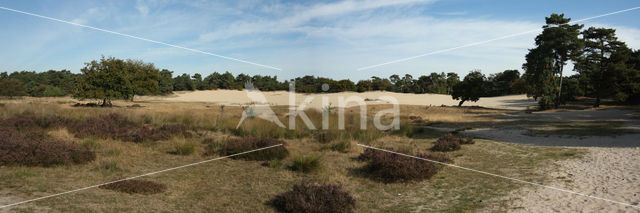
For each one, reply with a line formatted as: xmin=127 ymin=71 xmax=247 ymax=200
xmin=522 ymin=14 xmax=640 ymax=109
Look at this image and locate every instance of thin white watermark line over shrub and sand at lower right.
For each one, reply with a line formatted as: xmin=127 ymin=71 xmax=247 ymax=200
xmin=358 ymin=144 xmax=640 ymax=209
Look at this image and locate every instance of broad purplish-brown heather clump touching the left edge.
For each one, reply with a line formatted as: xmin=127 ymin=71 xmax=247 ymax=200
xmin=0 ymin=127 xmax=96 ymax=167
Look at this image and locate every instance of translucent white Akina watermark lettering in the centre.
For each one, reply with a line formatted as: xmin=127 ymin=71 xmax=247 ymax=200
xmin=236 ymin=81 xmax=400 ymax=130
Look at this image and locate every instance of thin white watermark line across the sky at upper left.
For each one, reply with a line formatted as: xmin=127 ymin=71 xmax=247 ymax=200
xmin=0 ymin=6 xmax=282 ymax=71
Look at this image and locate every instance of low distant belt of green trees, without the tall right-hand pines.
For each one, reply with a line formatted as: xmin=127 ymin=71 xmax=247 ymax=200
xmin=0 ymin=57 xmax=524 ymax=106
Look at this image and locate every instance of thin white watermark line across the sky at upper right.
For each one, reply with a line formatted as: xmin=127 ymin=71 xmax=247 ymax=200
xmin=357 ymin=7 xmax=640 ymax=71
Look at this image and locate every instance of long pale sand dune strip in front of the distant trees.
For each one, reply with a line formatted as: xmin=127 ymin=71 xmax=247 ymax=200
xmin=136 ymin=90 xmax=536 ymax=110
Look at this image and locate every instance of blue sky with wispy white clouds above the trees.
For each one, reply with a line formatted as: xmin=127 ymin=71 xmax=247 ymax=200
xmin=0 ymin=0 xmax=640 ymax=80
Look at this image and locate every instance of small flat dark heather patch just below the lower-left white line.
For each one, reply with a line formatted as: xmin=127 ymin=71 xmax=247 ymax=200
xmin=99 ymin=180 xmax=167 ymax=195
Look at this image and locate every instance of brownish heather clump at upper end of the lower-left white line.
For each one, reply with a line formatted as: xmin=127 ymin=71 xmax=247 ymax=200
xmin=205 ymin=137 xmax=289 ymax=161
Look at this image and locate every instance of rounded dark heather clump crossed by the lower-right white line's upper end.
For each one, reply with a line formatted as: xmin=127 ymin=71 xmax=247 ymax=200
xmin=358 ymin=149 xmax=450 ymax=183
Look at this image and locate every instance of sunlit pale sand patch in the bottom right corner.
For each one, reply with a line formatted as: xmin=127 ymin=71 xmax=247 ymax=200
xmin=506 ymin=148 xmax=640 ymax=212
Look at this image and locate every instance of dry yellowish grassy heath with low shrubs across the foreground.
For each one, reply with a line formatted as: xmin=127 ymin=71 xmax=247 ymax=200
xmin=0 ymin=98 xmax=581 ymax=212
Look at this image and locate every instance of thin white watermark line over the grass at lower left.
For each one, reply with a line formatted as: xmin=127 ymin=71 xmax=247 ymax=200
xmin=0 ymin=144 xmax=282 ymax=209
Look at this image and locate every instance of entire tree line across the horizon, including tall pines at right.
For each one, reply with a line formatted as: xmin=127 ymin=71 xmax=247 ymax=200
xmin=0 ymin=14 xmax=640 ymax=109
